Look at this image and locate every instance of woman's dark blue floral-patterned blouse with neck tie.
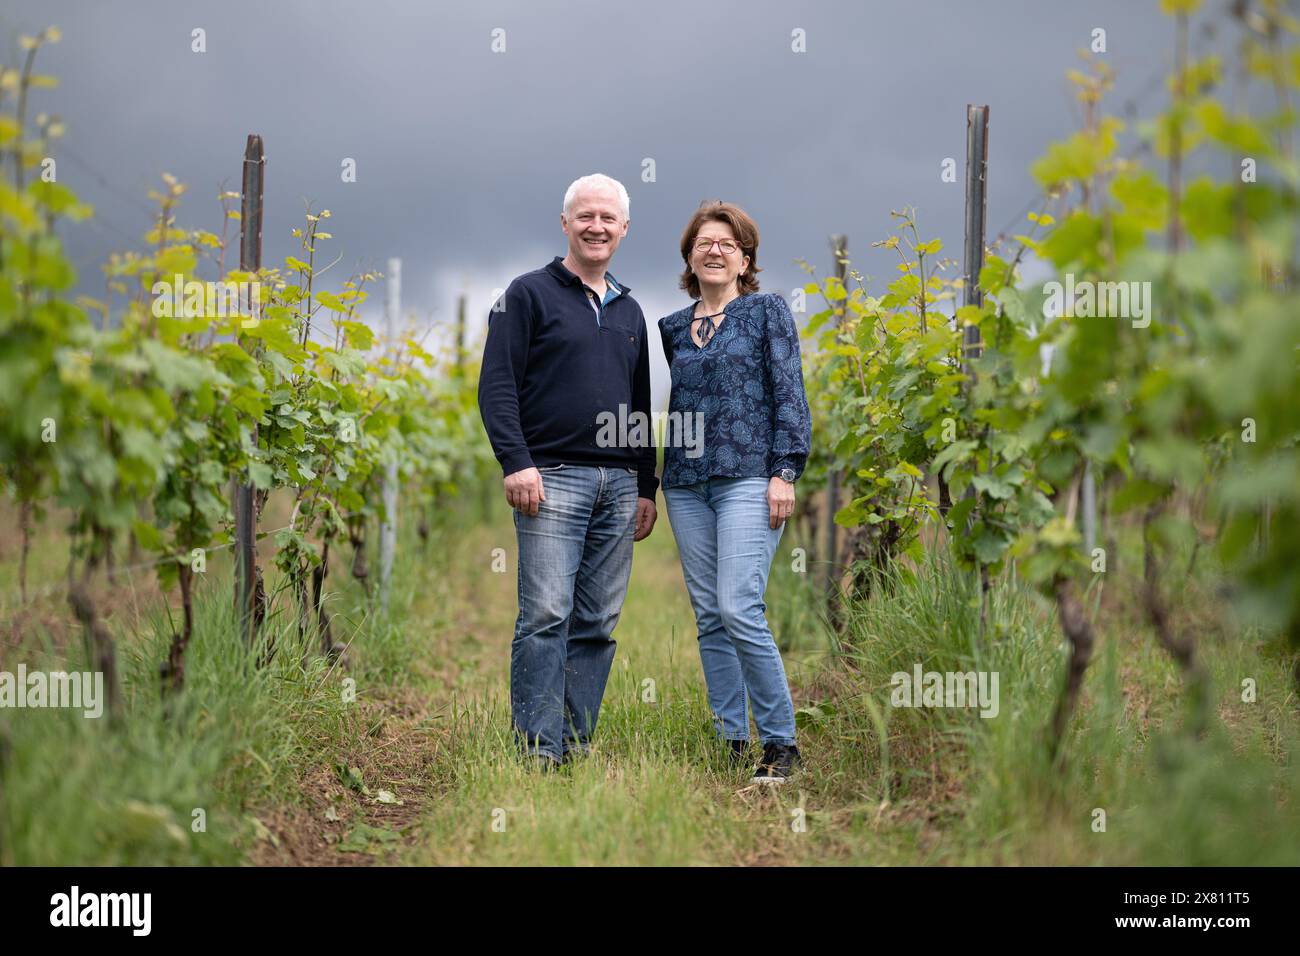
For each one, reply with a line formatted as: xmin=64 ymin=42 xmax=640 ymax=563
xmin=659 ymin=293 xmax=813 ymax=488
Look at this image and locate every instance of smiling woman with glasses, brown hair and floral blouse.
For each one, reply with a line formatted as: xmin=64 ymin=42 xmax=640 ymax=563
xmin=659 ymin=200 xmax=811 ymax=783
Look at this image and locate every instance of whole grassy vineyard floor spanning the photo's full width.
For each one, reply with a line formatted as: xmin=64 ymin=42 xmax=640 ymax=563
xmin=0 ymin=502 xmax=1300 ymax=866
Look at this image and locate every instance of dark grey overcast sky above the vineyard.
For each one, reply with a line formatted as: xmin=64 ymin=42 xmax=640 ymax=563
xmin=0 ymin=0 xmax=1222 ymax=402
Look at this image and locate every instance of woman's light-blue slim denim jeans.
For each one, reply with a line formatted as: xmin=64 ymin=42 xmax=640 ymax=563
xmin=663 ymin=477 xmax=794 ymax=744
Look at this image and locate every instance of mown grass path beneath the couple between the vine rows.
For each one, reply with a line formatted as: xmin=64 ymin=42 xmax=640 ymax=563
xmin=384 ymin=516 xmax=873 ymax=865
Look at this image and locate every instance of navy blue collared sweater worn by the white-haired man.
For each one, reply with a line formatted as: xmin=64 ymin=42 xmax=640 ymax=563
xmin=478 ymin=256 xmax=659 ymax=499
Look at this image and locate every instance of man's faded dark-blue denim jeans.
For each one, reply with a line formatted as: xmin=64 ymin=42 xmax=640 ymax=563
xmin=510 ymin=464 xmax=637 ymax=760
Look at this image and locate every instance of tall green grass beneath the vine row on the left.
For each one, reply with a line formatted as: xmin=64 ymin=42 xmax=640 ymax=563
xmin=0 ymin=515 xmax=436 ymax=865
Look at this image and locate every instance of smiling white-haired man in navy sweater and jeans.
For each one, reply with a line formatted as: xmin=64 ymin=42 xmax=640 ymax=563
xmin=478 ymin=174 xmax=659 ymax=769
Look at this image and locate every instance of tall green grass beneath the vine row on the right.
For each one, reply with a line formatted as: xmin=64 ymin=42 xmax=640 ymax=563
xmin=818 ymin=553 xmax=1300 ymax=865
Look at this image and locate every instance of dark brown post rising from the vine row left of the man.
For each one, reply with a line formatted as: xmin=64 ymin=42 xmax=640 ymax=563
xmin=234 ymin=133 xmax=267 ymax=645
